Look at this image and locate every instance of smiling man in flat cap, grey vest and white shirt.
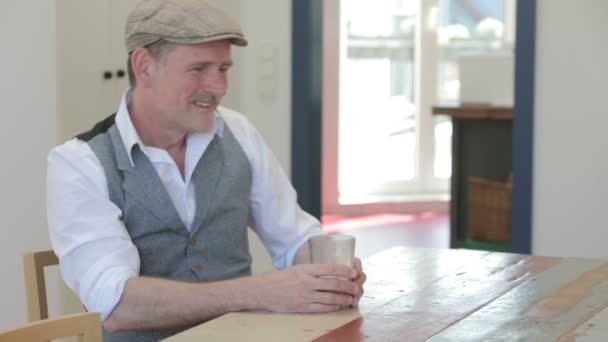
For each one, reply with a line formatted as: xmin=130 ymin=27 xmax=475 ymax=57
xmin=48 ymin=0 xmax=365 ymax=341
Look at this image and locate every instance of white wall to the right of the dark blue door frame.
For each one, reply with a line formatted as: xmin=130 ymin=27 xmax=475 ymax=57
xmin=532 ymin=0 xmax=608 ymax=258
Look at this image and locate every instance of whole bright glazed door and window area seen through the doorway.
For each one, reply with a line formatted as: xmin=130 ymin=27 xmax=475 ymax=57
xmin=323 ymin=0 xmax=514 ymax=211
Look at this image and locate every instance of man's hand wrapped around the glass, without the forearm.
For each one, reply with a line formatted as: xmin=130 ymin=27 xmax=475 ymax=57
xmin=252 ymin=259 xmax=365 ymax=312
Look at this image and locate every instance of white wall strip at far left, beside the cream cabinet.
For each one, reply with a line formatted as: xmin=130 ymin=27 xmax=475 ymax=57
xmin=0 ymin=0 xmax=56 ymax=329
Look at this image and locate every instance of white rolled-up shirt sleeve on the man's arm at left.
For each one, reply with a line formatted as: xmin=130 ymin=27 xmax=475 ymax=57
xmin=47 ymin=139 xmax=139 ymax=319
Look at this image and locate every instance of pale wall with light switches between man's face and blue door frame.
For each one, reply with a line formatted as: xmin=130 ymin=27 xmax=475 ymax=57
xmin=210 ymin=0 xmax=291 ymax=273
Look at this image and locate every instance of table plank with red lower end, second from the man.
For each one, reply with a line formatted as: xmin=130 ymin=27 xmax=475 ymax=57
xmin=316 ymin=253 xmax=559 ymax=341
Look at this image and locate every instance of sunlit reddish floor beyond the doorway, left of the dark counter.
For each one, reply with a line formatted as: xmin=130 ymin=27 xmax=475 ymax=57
xmin=321 ymin=212 xmax=450 ymax=258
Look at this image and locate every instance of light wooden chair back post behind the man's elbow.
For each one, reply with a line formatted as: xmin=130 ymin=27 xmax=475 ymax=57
xmin=23 ymin=250 xmax=59 ymax=322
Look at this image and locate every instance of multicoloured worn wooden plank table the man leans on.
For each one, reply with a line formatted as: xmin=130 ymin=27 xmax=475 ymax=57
xmin=166 ymin=247 xmax=608 ymax=342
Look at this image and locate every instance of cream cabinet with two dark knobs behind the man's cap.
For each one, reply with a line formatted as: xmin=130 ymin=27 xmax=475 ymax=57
xmin=56 ymin=0 xmax=138 ymax=142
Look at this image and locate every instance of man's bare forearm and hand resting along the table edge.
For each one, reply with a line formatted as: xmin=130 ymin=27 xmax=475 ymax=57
xmin=103 ymin=258 xmax=366 ymax=332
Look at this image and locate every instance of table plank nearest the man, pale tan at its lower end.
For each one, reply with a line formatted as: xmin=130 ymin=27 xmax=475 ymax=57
xmin=166 ymin=247 xmax=490 ymax=342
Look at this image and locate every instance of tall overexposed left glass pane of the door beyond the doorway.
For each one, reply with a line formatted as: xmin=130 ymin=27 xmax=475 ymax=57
xmin=338 ymin=0 xmax=419 ymax=199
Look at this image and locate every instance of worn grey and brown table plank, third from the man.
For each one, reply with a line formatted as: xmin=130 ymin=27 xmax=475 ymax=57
xmin=430 ymin=259 xmax=608 ymax=341
